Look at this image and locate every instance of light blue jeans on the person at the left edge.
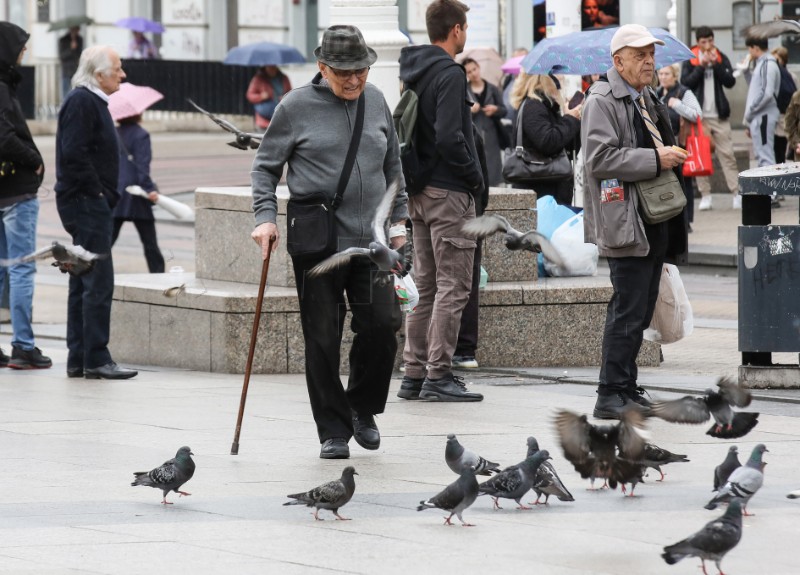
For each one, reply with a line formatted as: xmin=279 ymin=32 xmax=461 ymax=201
xmin=0 ymin=198 xmax=39 ymax=351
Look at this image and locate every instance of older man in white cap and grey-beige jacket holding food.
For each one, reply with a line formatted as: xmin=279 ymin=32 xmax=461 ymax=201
xmin=581 ymin=24 xmax=687 ymax=419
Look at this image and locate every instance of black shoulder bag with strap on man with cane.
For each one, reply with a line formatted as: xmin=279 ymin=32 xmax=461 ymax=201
xmin=286 ymin=92 xmax=364 ymax=256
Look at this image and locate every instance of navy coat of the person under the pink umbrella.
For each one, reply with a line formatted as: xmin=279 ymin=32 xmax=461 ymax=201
xmin=114 ymin=124 xmax=156 ymax=220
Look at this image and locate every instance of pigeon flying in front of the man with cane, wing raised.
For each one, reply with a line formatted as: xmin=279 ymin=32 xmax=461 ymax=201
xmin=308 ymin=178 xmax=405 ymax=277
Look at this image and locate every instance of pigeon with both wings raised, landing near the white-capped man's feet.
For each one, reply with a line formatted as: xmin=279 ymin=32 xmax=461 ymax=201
xmin=555 ymin=409 xmax=645 ymax=489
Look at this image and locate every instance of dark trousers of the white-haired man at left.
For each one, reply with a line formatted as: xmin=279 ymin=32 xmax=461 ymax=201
xmin=56 ymin=196 xmax=114 ymax=369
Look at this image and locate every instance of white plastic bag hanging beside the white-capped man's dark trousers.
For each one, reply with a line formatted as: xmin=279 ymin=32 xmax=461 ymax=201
xmin=644 ymin=264 xmax=694 ymax=344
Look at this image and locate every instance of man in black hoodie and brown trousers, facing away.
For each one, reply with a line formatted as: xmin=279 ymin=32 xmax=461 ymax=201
xmin=398 ymin=0 xmax=483 ymax=401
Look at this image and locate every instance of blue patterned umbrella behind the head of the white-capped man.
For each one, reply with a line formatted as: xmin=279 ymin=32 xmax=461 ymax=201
xmin=521 ymin=26 xmax=694 ymax=76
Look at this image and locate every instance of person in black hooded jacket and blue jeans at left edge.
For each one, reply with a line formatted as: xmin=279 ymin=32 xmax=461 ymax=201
xmin=0 ymin=22 xmax=53 ymax=369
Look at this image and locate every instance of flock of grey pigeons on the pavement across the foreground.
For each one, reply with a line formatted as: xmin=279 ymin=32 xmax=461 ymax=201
xmin=131 ymin=378 xmax=800 ymax=574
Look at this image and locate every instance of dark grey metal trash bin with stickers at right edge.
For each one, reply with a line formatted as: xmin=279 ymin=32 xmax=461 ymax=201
xmin=738 ymin=164 xmax=800 ymax=388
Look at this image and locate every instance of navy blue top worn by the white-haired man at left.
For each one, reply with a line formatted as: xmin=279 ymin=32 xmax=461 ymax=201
xmin=55 ymin=87 xmax=119 ymax=207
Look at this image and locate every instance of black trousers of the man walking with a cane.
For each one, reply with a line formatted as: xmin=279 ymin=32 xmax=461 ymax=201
xmin=292 ymin=257 xmax=401 ymax=443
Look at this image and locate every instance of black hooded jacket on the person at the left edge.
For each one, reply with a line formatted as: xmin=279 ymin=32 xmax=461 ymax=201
xmin=0 ymin=22 xmax=42 ymax=208
